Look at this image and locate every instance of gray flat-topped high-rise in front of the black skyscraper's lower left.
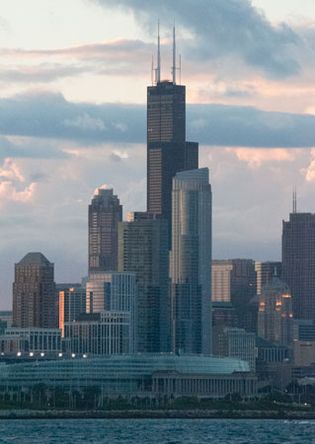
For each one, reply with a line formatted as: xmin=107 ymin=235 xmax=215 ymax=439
xmin=118 ymin=212 xmax=171 ymax=352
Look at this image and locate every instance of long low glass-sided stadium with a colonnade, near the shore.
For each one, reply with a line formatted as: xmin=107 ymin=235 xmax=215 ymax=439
xmin=0 ymin=353 xmax=257 ymax=402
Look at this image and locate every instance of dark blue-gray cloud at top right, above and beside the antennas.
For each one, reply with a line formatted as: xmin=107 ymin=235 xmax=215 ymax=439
xmin=92 ymin=0 xmax=302 ymax=78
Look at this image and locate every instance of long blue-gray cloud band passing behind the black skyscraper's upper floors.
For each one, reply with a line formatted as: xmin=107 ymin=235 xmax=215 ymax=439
xmin=0 ymin=93 xmax=315 ymax=151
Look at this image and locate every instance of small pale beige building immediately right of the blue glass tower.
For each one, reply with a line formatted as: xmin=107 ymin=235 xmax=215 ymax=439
xmin=211 ymin=260 xmax=233 ymax=302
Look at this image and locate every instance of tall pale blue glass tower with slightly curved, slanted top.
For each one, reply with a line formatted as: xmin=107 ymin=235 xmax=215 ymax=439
xmin=170 ymin=168 xmax=212 ymax=353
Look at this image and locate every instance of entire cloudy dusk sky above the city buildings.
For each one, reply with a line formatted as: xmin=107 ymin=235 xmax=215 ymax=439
xmin=0 ymin=0 xmax=315 ymax=309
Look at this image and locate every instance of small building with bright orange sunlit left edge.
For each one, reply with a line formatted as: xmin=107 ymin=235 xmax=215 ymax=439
xmin=58 ymin=286 xmax=86 ymax=336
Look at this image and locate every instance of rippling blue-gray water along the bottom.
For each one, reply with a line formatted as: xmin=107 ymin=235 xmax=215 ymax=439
xmin=0 ymin=419 xmax=315 ymax=444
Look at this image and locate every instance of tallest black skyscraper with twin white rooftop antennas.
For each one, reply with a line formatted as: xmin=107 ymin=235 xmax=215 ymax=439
xmin=147 ymin=29 xmax=198 ymax=236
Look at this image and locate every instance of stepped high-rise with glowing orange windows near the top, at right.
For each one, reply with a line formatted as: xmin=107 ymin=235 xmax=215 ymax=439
xmin=258 ymin=277 xmax=293 ymax=345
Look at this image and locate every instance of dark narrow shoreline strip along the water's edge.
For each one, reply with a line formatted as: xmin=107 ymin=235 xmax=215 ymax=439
xmin=0 ymin=410 xmax=315 ymax=420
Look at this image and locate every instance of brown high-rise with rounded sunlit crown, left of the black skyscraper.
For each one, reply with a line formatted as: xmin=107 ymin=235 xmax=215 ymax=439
xmin=89 ymin=185 xmax=122 ymax=273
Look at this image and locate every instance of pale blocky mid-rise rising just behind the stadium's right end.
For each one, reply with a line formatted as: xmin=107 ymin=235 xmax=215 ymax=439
xmin=219 ymin=328 xmax=256 ymax=372
